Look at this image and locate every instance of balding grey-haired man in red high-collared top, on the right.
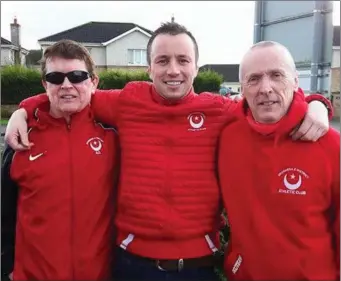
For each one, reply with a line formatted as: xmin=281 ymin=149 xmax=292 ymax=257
xmin=218 ymin=42 xmax=340 ymax=280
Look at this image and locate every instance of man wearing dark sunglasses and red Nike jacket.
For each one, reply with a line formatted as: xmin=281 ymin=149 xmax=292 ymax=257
xmin=1 ymin=40 xmax=118 ymax=280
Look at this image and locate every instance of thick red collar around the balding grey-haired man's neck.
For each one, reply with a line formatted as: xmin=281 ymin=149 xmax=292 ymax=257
xmin=239 ymin=89 xmax=308 ymax=137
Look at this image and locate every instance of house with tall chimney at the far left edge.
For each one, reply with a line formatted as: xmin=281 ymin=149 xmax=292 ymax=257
xmin=1 ymin=18 xmax=29 ymax=66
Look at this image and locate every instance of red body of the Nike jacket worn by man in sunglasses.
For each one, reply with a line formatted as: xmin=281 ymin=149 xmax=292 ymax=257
xmin=2 ymin=104 xmax=117 ymax=280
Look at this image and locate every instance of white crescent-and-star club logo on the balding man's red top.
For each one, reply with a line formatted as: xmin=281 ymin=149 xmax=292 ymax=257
xmin=278 ymin=168 xmax=309 ymax=195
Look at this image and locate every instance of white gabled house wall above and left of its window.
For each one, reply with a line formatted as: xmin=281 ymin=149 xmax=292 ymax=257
xmin=106 ymin=31 xmax=149 ymax=66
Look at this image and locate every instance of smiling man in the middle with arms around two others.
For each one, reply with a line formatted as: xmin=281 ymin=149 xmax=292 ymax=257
xmin=2 ymin=23 xmax=332 ymax=280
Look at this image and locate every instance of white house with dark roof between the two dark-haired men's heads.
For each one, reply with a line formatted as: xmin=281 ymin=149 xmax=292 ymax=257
xmin=38 ymin=22 xmax=152 ymax=69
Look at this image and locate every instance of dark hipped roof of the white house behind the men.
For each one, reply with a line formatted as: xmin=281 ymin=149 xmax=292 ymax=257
xmin=38 ymin=21 xmax=152 ymax=43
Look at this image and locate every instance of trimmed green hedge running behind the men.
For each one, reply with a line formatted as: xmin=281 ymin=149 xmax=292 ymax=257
xmin=1 ymin=66 xmax=223 ymax=104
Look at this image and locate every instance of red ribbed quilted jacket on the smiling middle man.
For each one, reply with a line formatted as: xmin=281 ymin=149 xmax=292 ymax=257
xmin=17 ymin=82 xmax=330 ymax=259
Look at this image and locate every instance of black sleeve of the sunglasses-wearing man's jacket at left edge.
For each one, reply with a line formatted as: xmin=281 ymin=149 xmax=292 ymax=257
xmin=1 ymin=145 xmax=18 ymax=278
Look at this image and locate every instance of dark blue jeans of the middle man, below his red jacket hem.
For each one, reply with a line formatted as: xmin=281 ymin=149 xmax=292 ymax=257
xmin=113 ymin=247 xmax=219 ymax=281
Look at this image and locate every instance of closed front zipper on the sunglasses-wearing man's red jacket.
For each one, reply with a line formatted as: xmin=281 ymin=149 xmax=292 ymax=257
xmin=67 ymin=123 xmax=76 ymax=280
